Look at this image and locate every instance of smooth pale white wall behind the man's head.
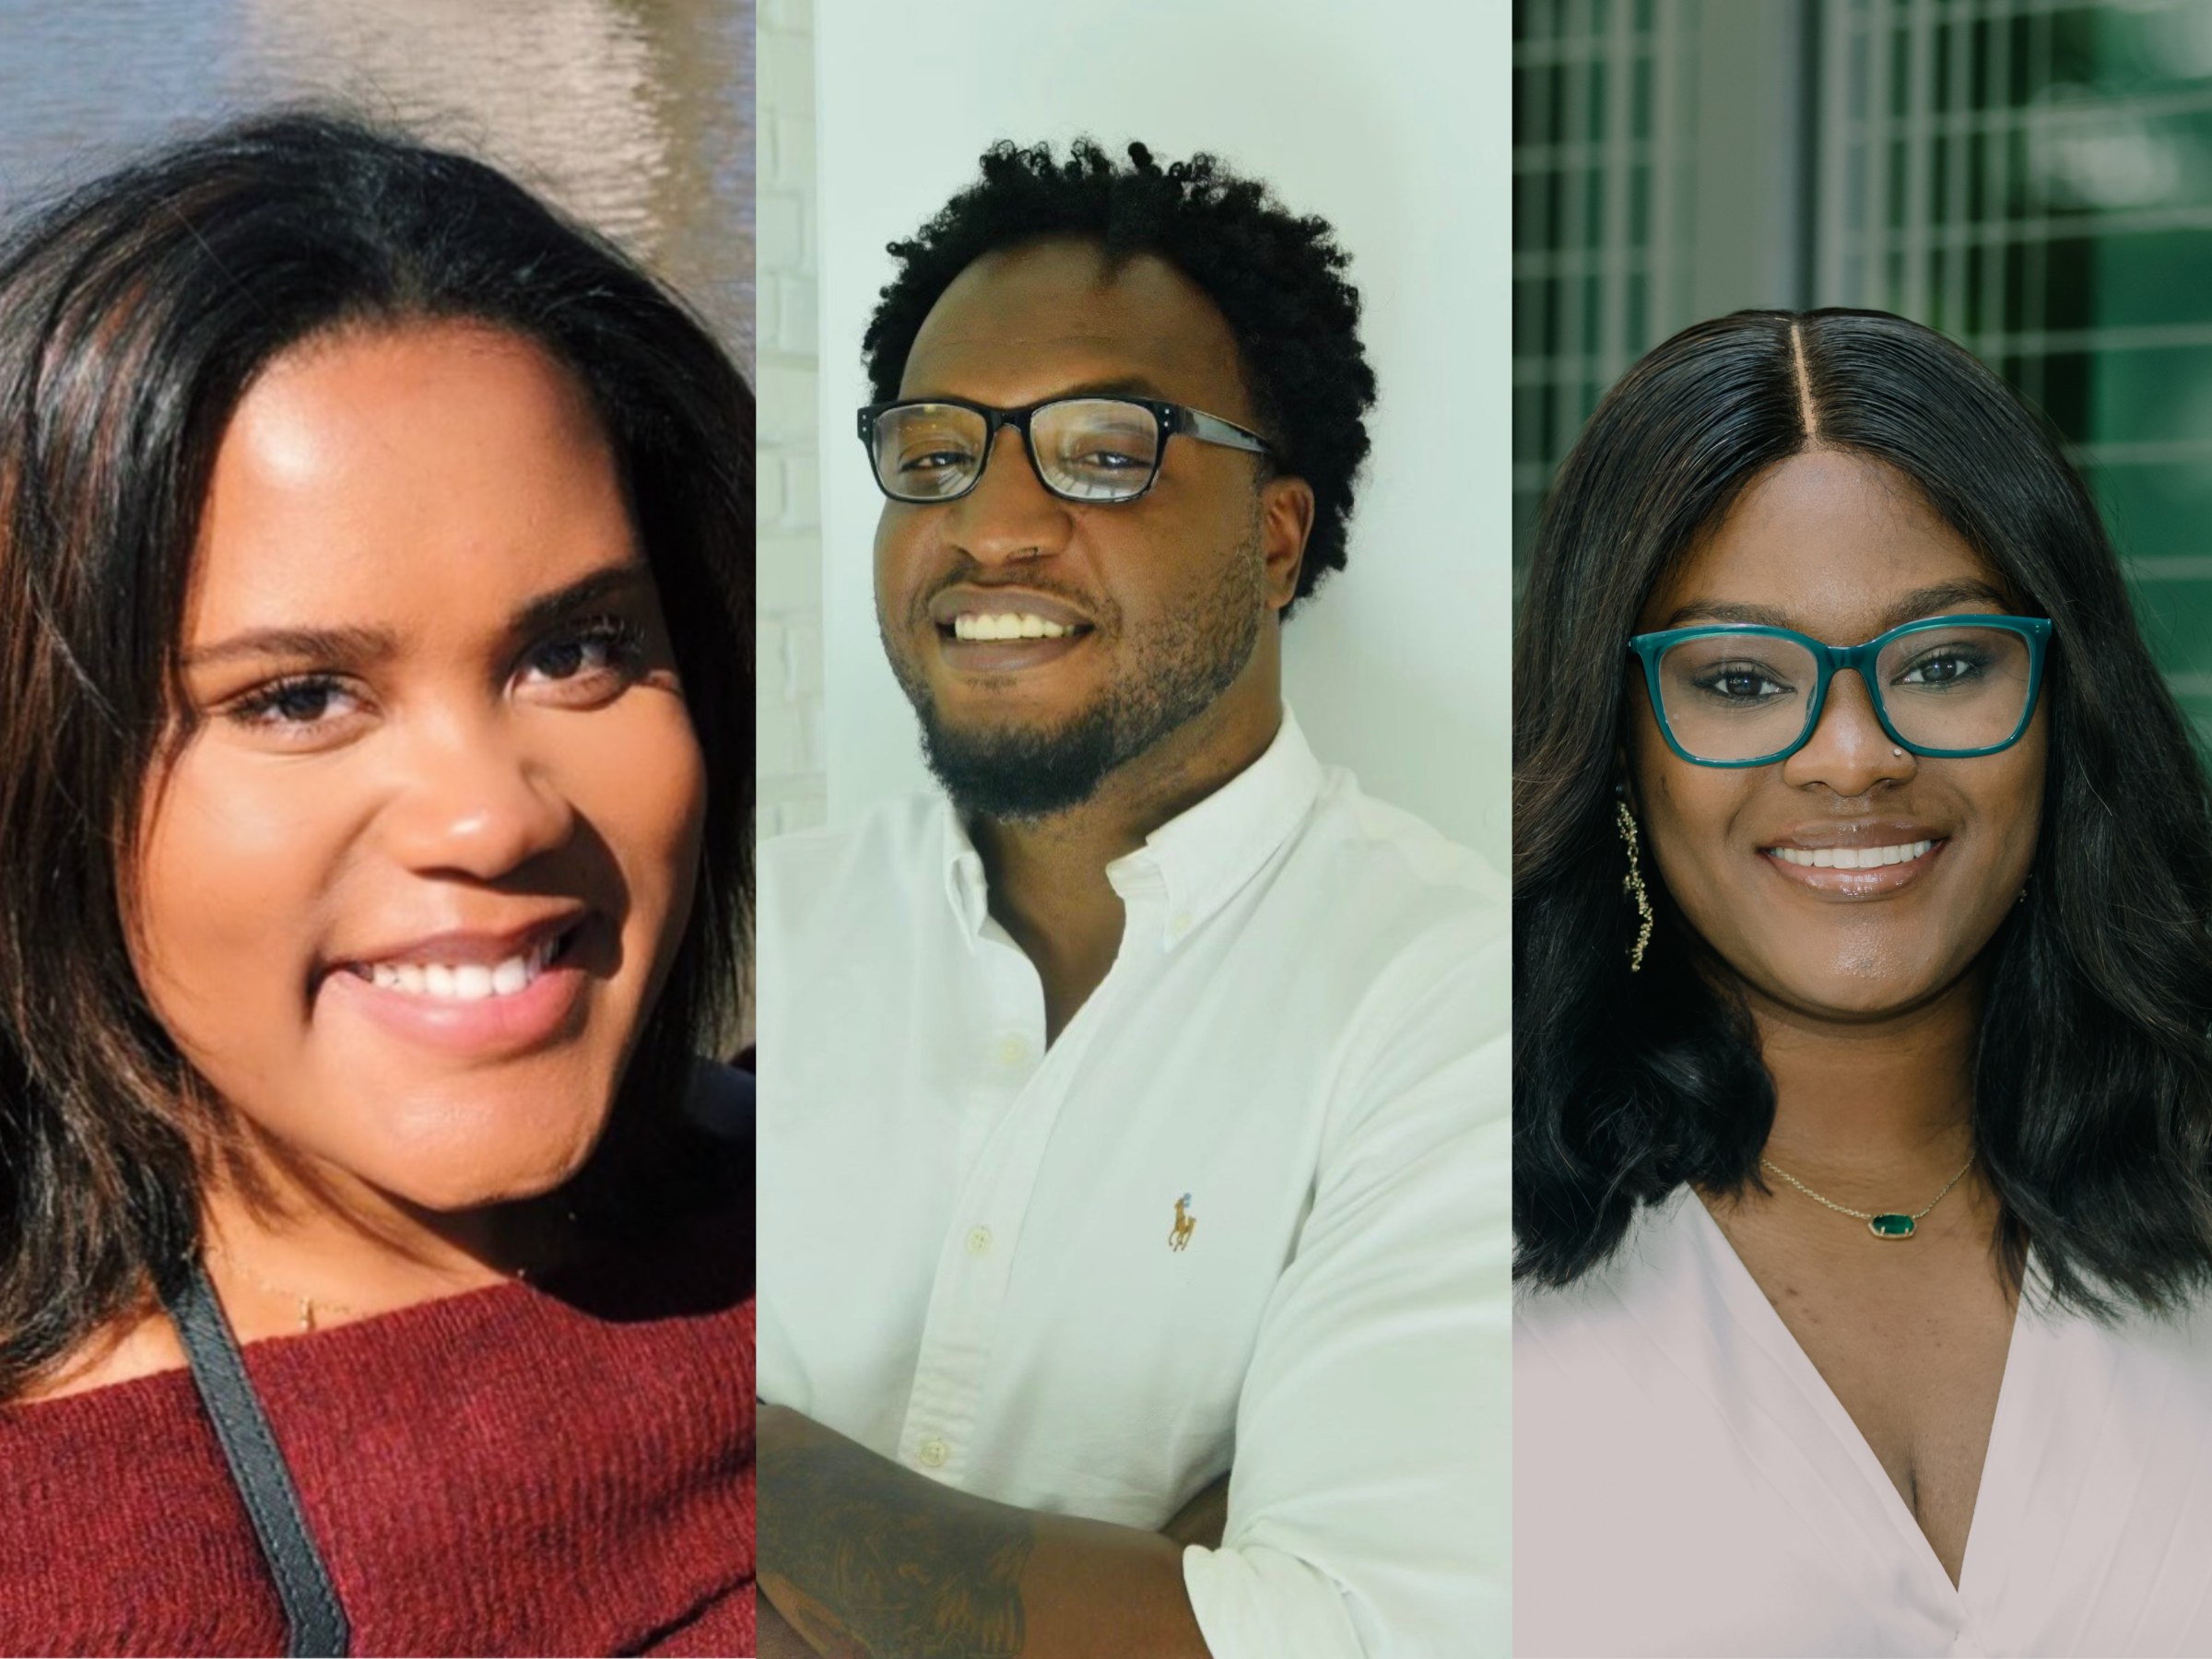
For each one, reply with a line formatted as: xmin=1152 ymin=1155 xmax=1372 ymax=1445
xmin=805 ymin=0 xmax=1511 ymax=869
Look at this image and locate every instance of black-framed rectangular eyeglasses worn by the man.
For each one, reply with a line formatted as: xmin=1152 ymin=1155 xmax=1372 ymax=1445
xmin=861 ymin=396 xmax=1274 ymax=504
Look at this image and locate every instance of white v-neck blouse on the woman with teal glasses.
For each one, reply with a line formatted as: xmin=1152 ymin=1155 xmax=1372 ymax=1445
xmin=1513 ymin=1190 xmax=2212 ymax=1659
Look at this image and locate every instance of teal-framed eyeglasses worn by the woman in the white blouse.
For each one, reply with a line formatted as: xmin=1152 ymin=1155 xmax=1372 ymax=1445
xmin=1628 ymin=615 xmax=2051 ymax=765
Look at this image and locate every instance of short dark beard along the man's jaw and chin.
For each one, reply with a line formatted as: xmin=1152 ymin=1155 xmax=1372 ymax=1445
xmin=885 ymin=511 xmax=1267 ymax=823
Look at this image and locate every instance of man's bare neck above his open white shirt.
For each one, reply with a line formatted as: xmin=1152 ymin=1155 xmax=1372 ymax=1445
xmin=971 ymin=681 xmax=1283 ymax=1040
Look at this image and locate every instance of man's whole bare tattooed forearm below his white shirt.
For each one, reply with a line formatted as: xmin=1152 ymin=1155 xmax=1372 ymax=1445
xmin=759 ymin=1405 xmax=1228 ymax=1659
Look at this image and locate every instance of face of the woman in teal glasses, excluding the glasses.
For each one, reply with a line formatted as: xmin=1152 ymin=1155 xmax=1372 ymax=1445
xmin=1630 ymin=449 xmax=2048 ymax=1019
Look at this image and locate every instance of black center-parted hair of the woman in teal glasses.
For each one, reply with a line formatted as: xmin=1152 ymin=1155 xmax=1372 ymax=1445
xmin=1513 ymin=310 xmax=2212 ymax=1314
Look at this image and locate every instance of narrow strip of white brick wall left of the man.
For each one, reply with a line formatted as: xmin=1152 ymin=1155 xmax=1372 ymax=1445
xmin=754 ymin=0 xmax=828 ymax=839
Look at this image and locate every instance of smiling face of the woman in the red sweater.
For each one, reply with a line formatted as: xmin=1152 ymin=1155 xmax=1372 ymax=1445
xmin=126 ymin=323 xmax=706 ymax=1210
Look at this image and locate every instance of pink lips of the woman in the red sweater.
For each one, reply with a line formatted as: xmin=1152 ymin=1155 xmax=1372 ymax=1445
xmin=316 ymin=912 xmax=591 ymax=1060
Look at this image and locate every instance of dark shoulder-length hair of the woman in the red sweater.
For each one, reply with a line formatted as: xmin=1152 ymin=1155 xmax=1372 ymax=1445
xmin=0 ymin=112 xmax=752 ymax=1400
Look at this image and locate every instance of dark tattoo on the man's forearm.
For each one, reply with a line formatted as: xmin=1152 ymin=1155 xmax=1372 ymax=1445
xmin=759 ymin=1444 xmax=1038 ymax=1659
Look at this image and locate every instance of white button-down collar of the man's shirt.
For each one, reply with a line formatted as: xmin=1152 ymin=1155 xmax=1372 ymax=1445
xmin=942 ymin=706 xmax=1321 ymax=951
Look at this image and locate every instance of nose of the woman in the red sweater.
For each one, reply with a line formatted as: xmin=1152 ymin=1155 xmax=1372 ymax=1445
xmin=385 ymin=712 xmax=575 ymax=883
